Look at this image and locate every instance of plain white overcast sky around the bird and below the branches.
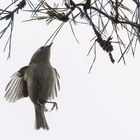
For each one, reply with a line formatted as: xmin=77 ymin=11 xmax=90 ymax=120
xmin=0 ymin=0 xmax=140 ymax=140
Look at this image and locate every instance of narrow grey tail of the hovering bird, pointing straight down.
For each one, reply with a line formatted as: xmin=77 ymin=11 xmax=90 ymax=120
xmin=35 ymin=104 xmax=49 ymax=130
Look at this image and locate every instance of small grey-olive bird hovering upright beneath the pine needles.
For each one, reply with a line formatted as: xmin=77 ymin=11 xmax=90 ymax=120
xmin=5 ymin=44 xmax=60 ymax=129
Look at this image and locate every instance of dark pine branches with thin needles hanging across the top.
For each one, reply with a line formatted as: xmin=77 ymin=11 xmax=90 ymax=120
xmin=0 ymin=0 xmax=140 ymax=70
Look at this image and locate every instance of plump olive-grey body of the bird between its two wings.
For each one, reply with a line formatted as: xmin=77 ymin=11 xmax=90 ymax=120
xmin=25 ymin=65 xmax=55 ymax=102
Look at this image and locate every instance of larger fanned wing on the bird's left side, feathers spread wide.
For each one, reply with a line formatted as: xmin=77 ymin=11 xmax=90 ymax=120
xmin=4 ymin=66 xmax=29 ymax=102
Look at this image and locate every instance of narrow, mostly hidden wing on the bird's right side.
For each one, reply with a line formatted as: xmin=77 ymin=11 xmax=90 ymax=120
xmin=54 ymin=68 xmax=60 ymax=97
